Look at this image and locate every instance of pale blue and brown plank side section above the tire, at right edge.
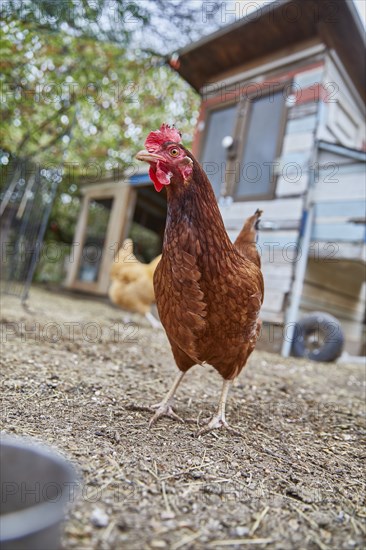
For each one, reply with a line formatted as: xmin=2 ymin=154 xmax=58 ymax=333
xmin=300 ymin=149 xmax=366 ymax=354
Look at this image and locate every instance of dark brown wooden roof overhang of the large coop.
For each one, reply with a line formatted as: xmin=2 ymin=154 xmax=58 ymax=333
xmin=171 ymin=0 xmax=366 ymax=97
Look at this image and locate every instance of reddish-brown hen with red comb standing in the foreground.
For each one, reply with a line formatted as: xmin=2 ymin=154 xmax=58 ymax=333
xmin=136 ymin=124 xmax=264 ymax=434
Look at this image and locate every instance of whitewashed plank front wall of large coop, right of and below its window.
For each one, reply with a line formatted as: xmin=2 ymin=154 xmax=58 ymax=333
xmin=221 ymin=63 xmax=324 ymax=323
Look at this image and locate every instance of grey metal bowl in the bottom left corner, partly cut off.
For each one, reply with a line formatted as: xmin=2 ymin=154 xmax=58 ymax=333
xmin=0 ymin=436 xmax=79 ymax=550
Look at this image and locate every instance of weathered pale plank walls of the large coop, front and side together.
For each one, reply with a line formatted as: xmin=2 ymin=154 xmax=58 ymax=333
xmin=195 ymin=50 xmax=366 ymax=353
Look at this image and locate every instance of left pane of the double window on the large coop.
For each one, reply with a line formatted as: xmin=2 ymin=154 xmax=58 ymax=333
xmin=201 ymin=105 xmax=238 ymax=197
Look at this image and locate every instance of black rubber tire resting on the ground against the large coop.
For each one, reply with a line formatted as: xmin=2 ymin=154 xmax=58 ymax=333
xmin=291 ymin=311 xmax=344 ymax=362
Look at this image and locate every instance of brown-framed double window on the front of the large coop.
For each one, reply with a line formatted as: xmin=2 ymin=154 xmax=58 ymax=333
xmin=200 ymin=89 xmax=285 ymax=200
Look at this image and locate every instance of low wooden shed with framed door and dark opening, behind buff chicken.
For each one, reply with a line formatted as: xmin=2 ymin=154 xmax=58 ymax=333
xmin=65 ymin=172 xmax=166 ymax=295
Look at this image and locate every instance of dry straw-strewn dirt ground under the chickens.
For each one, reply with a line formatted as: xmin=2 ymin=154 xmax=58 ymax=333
xmin=1 ymin=288 xmax=366 ymax=550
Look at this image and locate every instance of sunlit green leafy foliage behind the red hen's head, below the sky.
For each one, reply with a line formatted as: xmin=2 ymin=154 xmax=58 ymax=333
xmin=0 ymin=20 xmax=198 ymax=171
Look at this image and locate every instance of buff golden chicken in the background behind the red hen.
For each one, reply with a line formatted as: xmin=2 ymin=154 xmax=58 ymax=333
xmin=108 ymin=239 xmax=161 ymax=328
